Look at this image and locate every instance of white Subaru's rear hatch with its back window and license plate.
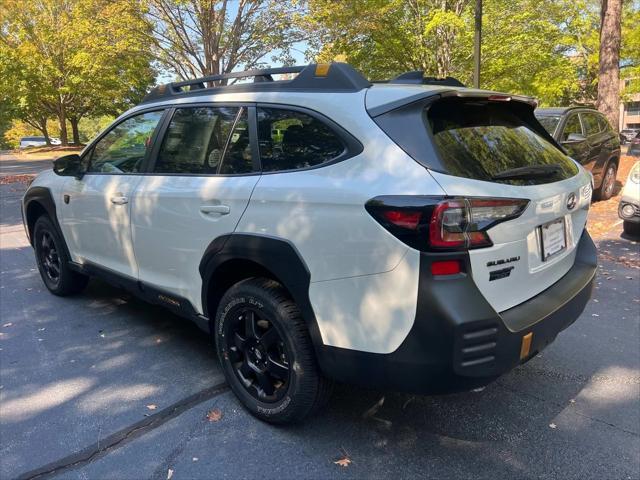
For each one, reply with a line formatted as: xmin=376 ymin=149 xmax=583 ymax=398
xmin=374 ymin=90 xmax=591 ymax=312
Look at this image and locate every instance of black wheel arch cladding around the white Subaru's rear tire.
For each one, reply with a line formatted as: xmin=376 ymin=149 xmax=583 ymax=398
xmin=199 ymin=233 xmax=322 ymax=350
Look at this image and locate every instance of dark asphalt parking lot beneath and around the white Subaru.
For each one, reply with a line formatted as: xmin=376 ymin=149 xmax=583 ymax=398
xmin=0 ymin=153 xmax=640 ymax=480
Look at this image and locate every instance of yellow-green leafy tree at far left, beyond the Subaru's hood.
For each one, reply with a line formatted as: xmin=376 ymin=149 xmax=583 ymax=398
xmin=0 ymin=0 xmax=154 ymax=145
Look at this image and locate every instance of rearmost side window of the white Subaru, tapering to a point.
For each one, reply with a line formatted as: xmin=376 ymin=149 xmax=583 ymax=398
xmin=258 ymin=108 xmax=345 ymax=172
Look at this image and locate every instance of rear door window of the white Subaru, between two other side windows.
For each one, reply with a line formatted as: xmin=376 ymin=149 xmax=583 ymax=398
xmin=154 ymin=107 xmax=240 ymax=174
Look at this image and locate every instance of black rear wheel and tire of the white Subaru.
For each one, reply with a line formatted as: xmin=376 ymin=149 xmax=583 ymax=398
xmin=213 ymin=278 xmax=332 ymax=424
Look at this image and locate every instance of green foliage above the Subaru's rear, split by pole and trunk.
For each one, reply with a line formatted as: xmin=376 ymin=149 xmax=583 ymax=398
xmin=304 ymin=0 xmax=640 ymax=105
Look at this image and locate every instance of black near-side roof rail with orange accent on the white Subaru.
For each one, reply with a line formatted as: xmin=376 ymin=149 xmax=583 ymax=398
xmin=142 ymin=63 xmax=371 ymax=103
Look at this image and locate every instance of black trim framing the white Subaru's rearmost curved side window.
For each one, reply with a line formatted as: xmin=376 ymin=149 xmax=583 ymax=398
xmin=255 ymin=102 xmax=364 ymax=175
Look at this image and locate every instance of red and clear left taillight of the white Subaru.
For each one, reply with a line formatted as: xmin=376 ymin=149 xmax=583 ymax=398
xmin=366 ymin=196 xmax=529 ymax=250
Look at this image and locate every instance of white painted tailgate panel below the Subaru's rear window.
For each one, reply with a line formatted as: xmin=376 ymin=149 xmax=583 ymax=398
xmin=431 ymin=167 xmax=591 ymax=312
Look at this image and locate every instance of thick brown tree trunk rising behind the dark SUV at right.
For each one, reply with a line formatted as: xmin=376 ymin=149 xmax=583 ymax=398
xmin=597 ymin=0 xmax=622 ymax=132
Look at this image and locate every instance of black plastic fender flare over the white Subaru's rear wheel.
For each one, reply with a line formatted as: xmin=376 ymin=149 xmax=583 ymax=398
xmin=199 ymin=233 xmax=323 ymax=353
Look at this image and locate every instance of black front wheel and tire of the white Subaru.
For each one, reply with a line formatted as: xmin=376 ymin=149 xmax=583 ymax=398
xmin=33 ymin=215 xmax=89 ymax=297
